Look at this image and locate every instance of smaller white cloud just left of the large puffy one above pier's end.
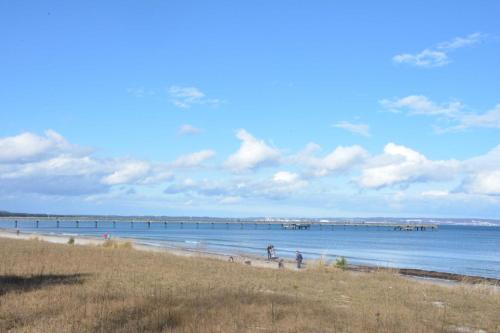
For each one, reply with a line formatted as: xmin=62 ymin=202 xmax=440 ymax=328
xmin=291 ymin=143 xmax=368 ymax=177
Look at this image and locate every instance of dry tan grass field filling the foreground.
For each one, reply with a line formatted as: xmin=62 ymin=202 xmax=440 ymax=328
xmin=0 ymin=239 xmax=500 ymax=333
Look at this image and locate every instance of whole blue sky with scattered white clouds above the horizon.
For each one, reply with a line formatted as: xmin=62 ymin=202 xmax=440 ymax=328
xmin=0 ymin=1 xmax=500 ymax=218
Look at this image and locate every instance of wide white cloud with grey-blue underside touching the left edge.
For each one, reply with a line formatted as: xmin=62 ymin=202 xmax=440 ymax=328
xmin=0 ymin=131 xmax=178 ymax=195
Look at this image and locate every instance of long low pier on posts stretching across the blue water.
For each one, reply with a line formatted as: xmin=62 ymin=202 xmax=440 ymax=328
xmin=0 ymin=217 xmax=438 ymax=231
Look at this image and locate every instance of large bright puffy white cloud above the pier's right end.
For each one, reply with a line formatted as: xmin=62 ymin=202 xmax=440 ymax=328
xmin=358 ymin=143 xmax=460 ymax=189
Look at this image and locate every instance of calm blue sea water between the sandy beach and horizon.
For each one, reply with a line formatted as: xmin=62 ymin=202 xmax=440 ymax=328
xmin=0 ymin=221 xmax=500 ymax=278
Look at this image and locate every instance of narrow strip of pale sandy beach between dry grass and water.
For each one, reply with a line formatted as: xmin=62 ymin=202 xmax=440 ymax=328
xmin=0 ymin=228 xmax=500 ymax=287
